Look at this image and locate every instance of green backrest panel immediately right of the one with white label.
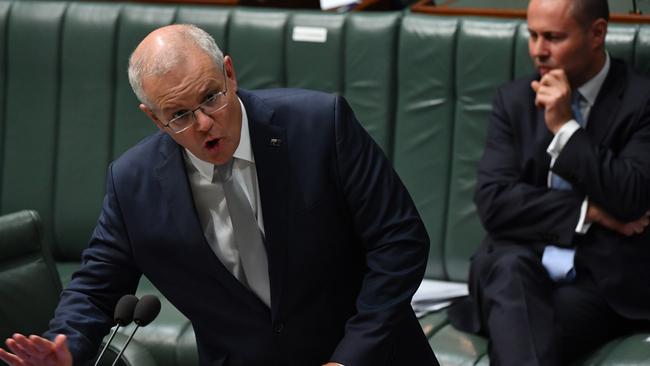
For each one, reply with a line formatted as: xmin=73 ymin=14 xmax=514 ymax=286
xmin=342 ymin=12 xmax=401 ymax=158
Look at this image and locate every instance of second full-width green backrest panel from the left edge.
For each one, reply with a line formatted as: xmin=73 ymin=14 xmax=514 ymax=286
xmin=54 ymin=2 xmax=121 ymax=261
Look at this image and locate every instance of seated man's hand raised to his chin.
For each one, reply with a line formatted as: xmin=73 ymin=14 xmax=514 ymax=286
xmin=530 ymin=69 xmax=573 ymax=135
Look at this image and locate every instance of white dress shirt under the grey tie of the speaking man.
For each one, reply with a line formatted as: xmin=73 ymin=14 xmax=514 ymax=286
xmin=184 ymin=99 xmax=264 ymax=279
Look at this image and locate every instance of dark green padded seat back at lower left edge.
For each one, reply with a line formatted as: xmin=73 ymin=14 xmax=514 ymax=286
xmin=0 ymin=211 xmax=61 ymax=339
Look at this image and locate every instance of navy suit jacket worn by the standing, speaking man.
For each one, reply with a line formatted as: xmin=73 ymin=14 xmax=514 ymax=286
xmin=48 ymin=90 xmax=435 ymax=366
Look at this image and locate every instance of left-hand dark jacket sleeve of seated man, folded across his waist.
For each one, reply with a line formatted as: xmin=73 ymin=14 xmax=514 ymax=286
xmin=475 ymin=88 xmax=584 ymax=245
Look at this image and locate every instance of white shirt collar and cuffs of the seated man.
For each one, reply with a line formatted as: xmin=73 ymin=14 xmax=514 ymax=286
xmin=546 ymin=53 xmax=611 ymax=234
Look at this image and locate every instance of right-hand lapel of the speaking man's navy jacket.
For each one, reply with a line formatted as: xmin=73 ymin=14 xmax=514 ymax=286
xmin=238 ymin=90 xmax=289 ymax=318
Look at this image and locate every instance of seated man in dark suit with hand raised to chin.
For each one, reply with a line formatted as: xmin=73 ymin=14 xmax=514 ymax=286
xmin=451 ymin=0 xmax=650 ymax=366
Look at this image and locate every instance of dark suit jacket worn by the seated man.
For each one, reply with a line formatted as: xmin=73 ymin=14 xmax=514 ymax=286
xmin=452 ymin=59 xmax=650 ymax=331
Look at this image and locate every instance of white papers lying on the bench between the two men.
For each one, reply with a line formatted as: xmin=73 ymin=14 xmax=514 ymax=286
xmin=411 ymin=279 xmax=469 ymax=318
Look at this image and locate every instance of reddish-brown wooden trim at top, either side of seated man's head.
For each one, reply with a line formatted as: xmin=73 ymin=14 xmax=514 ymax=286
xmin=411 ymin=0 xmax=650 ymax=23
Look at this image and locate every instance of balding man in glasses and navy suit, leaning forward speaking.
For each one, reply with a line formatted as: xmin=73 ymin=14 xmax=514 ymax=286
xmin=0 ymin=25 xmax=437 ymax=366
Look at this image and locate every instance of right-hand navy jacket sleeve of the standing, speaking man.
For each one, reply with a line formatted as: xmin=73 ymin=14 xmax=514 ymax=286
xmin=332 ymin=98 xmax=429 ymax=366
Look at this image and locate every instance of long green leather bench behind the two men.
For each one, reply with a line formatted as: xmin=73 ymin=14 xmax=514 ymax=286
xmin=0 ymin=1 xmax=650 ymax=365
